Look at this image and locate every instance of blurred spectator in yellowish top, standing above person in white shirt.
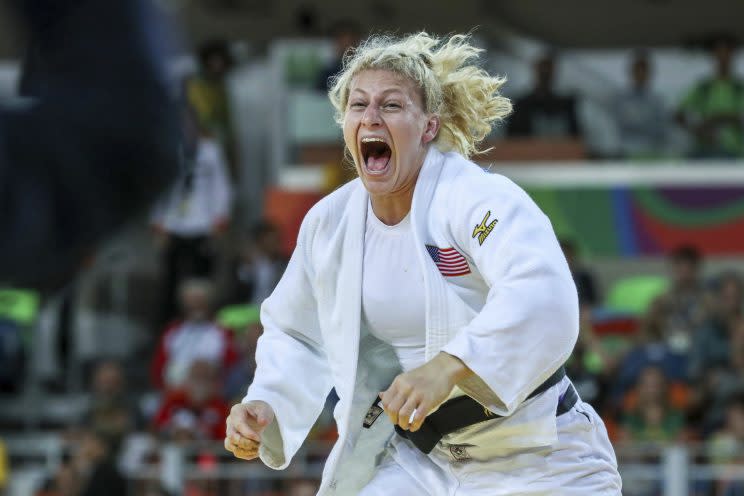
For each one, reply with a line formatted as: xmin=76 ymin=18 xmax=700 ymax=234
xmin=185 ymin=40 xmax=238 ymax=176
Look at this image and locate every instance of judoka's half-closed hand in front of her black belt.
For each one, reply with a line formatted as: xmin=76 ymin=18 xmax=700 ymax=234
xmin=380 ymin=352 xmax=473 ymax=432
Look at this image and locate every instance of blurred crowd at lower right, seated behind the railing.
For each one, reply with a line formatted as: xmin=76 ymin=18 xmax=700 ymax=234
xmin=564 ymin=242 xmax=744 ymax=496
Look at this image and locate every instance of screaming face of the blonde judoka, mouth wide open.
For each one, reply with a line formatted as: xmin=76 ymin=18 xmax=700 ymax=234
xmin=344 ymin=70 xmax=439 ymax=200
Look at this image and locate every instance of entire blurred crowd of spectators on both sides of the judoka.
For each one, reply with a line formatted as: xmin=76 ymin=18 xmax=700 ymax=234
xmin=0 ymin=18 xmax=744 ymax=496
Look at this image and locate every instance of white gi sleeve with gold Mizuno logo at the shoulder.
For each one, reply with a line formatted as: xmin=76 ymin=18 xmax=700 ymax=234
xmin=442 ymin=174 xmax=579 ymax=415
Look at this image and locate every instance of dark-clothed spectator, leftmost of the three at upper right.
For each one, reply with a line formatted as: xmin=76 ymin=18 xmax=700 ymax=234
xmin=507 ymin=53 xmax=581 ymax=138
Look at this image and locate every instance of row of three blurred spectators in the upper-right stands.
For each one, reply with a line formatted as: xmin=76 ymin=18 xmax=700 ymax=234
xmin=507 ymin=36 xmax=744 ymax=159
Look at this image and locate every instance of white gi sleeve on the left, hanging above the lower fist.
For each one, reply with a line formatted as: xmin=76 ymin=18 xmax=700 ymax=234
xmin=243 ymin=211 xmax=332 ymax=469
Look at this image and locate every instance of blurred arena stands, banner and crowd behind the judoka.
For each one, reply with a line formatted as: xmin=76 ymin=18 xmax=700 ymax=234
xmin=0 ymin=0 xmax=744 ymax=496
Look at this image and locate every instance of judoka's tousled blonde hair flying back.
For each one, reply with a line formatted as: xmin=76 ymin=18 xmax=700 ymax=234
xmin=328 ymin=31 xmax=512 ymax=157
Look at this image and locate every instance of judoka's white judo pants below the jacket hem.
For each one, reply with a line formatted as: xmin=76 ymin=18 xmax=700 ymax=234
xmin=359 ymin=400 xmax=621 ymax=496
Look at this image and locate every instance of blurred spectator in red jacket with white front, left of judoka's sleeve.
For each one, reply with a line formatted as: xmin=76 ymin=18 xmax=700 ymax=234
xmin=151 ymin=279 xmax=237 ymax=388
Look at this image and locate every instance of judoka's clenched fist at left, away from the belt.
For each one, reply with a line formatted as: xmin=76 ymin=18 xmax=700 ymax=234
xmin=225 ymin=401 xmax=274 ymax=460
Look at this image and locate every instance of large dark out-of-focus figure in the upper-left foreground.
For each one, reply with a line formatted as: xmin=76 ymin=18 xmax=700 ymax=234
xmin=0 ymin=0 xmax=178 ymax=285
